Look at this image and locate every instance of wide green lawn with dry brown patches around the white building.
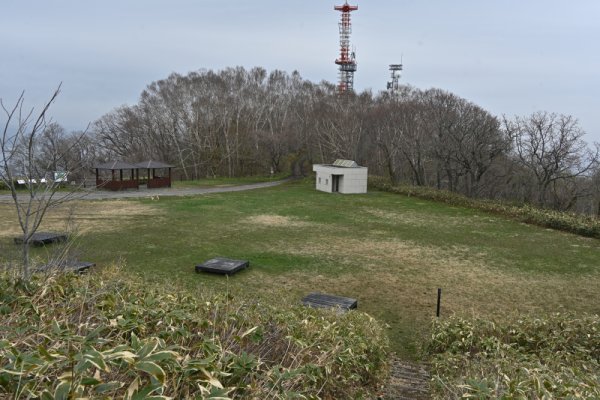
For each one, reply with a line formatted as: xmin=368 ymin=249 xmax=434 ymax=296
xmin=0 ymin=181 xmax=600 ymax=358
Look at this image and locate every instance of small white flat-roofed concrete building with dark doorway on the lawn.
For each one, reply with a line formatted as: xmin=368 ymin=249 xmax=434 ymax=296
xmin=313 ymin=160 xmax=368 ymax=194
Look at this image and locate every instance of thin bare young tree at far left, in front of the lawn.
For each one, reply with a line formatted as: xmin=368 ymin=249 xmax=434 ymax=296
xmin=0 ymin=85 xmax=83 ymax=280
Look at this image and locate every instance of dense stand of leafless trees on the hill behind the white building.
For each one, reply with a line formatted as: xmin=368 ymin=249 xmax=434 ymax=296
xmin=31 ymin=67 xmax=600 ymax=215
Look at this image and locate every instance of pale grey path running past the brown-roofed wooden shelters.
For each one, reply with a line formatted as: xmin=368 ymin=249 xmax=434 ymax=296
xmin=0 ymin=179 xmax=289 ymax=203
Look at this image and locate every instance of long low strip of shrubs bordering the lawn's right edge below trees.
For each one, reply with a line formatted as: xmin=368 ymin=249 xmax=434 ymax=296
xmin=369 ymin=177 xmax=600 ymax=238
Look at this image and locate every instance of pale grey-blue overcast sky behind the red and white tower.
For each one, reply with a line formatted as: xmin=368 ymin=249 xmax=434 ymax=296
xmin=0 ymin=0 xmax=600 ymax=142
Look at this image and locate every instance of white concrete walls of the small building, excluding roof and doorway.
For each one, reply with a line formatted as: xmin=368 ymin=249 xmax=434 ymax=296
xmin=313 ymin=164 xmax=368 ymax=194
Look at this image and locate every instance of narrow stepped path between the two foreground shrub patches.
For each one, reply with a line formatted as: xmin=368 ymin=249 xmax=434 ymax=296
xmin=380 ymin=357 xmax=431 ymax=400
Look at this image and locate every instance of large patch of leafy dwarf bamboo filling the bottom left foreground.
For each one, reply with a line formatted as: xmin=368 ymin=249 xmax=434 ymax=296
xmin=0 ymin=269 xmax=387 ymax=400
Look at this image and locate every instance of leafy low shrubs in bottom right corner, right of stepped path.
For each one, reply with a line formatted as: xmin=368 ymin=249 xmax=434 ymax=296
xmin=427 ymin=314 xmax=600 ymax=399
